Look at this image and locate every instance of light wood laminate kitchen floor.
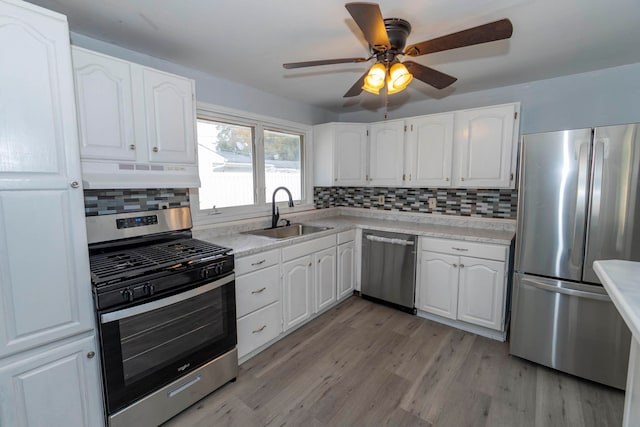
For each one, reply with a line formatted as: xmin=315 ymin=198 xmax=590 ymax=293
xmin=165 ymin=297 xmax=624 ymax=427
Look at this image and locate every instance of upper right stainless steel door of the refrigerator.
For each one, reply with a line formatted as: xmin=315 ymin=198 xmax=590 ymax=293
xmin=583 ymin=124 xmax=640 ymax=283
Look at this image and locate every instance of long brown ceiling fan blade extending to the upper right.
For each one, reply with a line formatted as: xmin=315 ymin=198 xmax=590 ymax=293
xmin=405 ymin=19 xmax=513 ymax=56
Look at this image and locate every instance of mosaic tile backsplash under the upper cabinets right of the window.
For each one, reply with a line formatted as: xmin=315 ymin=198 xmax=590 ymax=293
xmin=313 ymin=187 xmax=518 ymax=219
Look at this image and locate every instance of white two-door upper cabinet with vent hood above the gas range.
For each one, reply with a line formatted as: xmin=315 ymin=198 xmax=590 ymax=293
xmin=72 ymin=47 xmax=200 ymax=188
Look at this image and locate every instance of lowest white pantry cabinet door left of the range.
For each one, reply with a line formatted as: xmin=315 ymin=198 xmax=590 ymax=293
xmin=0 ymin=336 xmax=104 ymax=427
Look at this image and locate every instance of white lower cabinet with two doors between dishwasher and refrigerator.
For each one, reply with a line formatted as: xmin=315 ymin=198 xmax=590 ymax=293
xmin=418 ymin=238 xmax=509 ymax=338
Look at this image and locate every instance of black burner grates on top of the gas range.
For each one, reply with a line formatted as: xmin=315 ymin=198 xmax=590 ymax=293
xmin=89 ymin=239 xmax=230 ymax=284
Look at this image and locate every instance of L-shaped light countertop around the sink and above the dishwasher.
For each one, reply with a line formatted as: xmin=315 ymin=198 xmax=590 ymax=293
xmin=194 ymin=215 xmax=515 ymax=257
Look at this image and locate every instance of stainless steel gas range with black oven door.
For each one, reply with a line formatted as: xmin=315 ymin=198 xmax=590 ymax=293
xmin=87 ymin=208 xmax=238 ymax=427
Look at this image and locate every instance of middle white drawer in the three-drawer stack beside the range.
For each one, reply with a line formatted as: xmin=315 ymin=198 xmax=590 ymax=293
xmin=236 ymin=265 xmax=280 ymax=318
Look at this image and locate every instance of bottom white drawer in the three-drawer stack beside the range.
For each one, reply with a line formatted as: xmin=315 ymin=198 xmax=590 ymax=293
xmin=238 ymin=302 xmax=282 ymax=357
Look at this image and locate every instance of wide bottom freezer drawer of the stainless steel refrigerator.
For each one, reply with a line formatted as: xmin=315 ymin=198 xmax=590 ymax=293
xmin=510 ymin=274 xmax=631 ymax=389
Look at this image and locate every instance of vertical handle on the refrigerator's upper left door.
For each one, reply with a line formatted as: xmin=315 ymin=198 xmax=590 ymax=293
xmin=571 ymin=142 xmax=589 ymax=268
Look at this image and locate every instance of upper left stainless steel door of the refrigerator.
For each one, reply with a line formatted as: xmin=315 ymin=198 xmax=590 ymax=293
xmin=516 ymin=129 xmax=591 ymax=281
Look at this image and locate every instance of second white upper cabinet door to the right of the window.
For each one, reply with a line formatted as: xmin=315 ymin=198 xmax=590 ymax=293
xmin=369 ymin=121 xmax=404 ymax=186
